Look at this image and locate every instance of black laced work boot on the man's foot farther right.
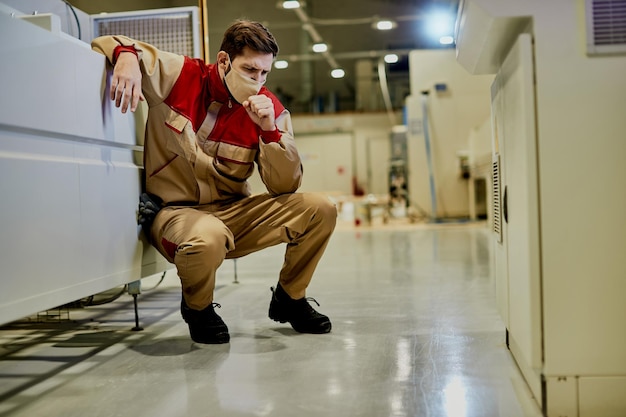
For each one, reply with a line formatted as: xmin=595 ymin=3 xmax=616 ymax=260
xmin=269 ymin=284 xmax=332 ymax=334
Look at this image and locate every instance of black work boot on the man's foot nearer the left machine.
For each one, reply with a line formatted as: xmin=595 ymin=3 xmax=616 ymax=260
xmin=180 ymin=298 xmax=230 ymax=344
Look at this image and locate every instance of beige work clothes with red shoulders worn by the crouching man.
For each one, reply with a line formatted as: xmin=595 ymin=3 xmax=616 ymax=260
xmin=92 ymin=36 xmax=337 ymax=310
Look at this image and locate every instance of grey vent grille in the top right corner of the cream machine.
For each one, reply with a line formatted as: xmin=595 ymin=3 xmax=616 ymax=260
xmin=587 ymin=0 xmax=626 ymax=54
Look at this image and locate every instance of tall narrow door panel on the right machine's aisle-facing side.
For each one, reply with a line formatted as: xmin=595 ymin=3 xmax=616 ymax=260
xmin=493 ymin=34 xmax=542 ymax=369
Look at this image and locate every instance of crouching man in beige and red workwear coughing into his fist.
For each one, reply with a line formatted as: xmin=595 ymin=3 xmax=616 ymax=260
xmin=92 ymin=21 xmax=337 ymax=343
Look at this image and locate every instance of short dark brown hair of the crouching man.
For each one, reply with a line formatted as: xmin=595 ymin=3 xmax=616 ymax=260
xmin=220 ymin=20 xmax=278 ymax=59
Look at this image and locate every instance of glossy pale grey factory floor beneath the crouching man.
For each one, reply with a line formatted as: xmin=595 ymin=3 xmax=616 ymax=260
xmin=0 ymin=224 xmax=540 ymax=417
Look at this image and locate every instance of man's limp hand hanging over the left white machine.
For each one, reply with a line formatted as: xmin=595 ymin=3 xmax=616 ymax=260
xmin=111 ymin=52 xmax=145 ymax=113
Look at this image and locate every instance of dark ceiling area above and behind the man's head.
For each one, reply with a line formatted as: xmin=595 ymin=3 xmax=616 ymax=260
xmin=71 ymin=0 xmax=458 ymax=113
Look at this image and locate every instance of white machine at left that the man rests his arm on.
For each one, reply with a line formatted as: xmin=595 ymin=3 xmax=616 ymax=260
xmin=0 ymin=2 xmax=199 ymax=324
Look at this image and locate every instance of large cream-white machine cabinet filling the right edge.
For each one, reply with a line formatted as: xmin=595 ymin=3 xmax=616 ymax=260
xmin=456 ymin=0 xmax=626 ymax=417
